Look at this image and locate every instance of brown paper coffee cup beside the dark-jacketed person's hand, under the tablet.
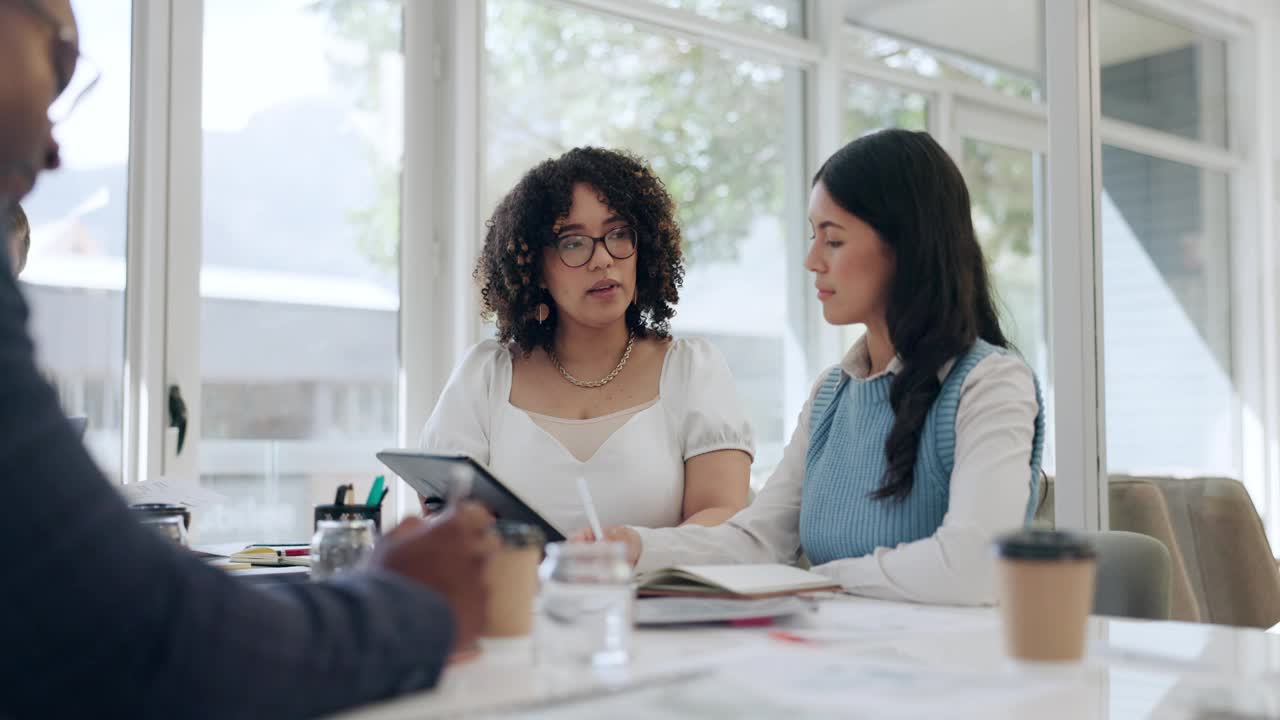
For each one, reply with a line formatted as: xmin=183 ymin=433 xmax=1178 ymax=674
xmin=480 ymin=521 xmax=547 ymax=638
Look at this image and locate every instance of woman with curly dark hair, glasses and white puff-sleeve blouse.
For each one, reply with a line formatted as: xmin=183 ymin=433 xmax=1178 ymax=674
xmin=421 ymin=147 xmax=754 ymax=532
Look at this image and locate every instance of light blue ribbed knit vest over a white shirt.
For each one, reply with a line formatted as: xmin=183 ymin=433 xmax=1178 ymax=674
xmin=800 ymin=340 xmax=1044 ymax=565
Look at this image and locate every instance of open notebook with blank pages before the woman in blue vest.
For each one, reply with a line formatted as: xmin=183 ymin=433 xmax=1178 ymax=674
xmin=636 ymin=564 xmax=840 ymax=598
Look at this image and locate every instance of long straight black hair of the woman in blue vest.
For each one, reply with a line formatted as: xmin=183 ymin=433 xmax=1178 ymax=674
xmin=813 ymin=129 xmax=1010 ymax=500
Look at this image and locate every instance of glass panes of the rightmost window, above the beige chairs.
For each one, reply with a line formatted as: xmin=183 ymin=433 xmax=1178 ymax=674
xmin=1100 ymin=4 xmax=1242 ymax=478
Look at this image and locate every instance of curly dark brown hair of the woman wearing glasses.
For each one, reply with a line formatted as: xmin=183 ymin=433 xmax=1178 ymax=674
xmin=475 ymin=147 xmax=685 ymax=355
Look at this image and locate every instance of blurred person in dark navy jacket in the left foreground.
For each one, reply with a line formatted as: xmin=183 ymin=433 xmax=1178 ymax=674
xmin=0 ymin=0 xmax=497 ymax=717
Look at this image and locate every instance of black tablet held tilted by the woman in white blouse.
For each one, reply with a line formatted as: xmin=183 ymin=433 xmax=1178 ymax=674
xmin=378 ymin=450 xmax=564 ymax=542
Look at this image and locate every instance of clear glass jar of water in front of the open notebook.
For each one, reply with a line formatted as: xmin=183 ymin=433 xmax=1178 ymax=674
xmin=534 ymin=542 xmax=635 ymax=666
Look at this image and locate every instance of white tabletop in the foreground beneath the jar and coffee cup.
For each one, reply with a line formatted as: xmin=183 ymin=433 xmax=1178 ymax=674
xmin=343 ymin=596 xmax=1280 ymax=720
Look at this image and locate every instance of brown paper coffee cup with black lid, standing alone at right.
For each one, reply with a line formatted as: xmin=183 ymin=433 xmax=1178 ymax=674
xmin=996 ymin=530 xmax=1097 ymax=662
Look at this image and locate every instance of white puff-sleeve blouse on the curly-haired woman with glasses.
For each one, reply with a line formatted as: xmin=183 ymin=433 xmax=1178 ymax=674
xmin=420 ymin=338 xmax=754 ymax=534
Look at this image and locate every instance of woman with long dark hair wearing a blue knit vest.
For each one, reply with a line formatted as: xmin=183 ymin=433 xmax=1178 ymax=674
xmin=579 ymin=129 xmax=1044 ymax=605
